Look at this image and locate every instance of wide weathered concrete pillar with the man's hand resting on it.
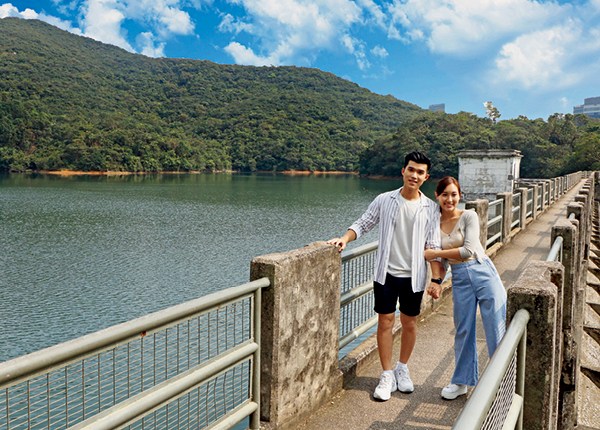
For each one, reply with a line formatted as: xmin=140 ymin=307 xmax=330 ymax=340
xmin=250 ymin=242 xmax=342 ymax=429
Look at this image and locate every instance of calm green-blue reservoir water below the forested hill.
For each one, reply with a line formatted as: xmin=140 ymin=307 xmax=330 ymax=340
xmin=0 ymin=174 xmax=434 ymax=362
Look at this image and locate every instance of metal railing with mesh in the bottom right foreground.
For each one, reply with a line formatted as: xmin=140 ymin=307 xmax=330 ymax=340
xmin=452 ymin=309 xmax=529 ymax=430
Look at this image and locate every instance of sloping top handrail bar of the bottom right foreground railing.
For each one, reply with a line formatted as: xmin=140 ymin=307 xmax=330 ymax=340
xmin=452 ymin=309 xmax=529 ymax=430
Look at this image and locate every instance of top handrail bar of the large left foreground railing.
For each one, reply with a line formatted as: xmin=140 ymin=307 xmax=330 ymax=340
xmin=0 ymin=278 xmax=270 ymax=389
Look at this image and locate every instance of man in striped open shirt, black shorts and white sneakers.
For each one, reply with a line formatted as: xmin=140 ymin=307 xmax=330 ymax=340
xmin=327 ymin=151 xmax=444 ymax=400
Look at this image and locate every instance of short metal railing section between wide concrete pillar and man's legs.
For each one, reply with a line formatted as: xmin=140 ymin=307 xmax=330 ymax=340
xmin=339 ymin=242 xmax=379 ymax=349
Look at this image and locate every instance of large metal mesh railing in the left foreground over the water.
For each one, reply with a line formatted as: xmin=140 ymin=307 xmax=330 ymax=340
xmin=0 ymin=278 xmax=269 ymax=430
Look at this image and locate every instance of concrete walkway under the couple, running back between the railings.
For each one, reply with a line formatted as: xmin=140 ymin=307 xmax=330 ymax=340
xmin=297 ymin=181 xmax=584 ymax=430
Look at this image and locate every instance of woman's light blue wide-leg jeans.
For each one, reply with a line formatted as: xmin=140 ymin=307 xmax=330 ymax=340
xmin=451 ymin=257 xmax=506 ymax=386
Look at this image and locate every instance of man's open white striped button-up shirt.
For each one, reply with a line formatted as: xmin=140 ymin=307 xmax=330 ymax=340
xmin=350 ymin=188 xmax=442 ymax=292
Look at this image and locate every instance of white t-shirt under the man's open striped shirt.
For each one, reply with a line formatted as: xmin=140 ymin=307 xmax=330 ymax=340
xmin=388 ymin=194 xmax=420 ymax=278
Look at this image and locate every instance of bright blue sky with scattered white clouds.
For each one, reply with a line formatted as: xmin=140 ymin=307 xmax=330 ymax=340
xmin=0 ymin=0 xmax=600 ymax=119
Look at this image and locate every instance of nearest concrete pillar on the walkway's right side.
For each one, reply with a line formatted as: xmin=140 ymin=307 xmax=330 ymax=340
xmin=507 ymin=261 xmax=563 ymax=430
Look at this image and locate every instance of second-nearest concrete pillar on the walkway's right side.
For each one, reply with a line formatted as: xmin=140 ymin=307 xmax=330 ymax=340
xmin=551 ymin=218 xmax=581 ymax=430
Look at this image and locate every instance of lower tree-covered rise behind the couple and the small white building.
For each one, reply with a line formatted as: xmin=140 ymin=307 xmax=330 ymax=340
xmin=360 ymin=112 xmax=600 ymax=178
